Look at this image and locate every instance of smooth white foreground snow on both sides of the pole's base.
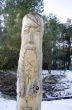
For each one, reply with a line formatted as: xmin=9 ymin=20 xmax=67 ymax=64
xmin=0 ymin=97 xmax=72 ymax=110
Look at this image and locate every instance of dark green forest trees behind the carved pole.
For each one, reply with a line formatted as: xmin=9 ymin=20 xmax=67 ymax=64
xmin=0 ymin=0 xmax=72 ymax=70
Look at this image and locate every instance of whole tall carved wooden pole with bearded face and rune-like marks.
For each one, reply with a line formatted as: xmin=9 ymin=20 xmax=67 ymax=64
xmin=17 ymin=13 xmax=44 ymax=110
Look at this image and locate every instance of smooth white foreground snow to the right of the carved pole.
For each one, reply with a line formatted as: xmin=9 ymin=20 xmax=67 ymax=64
xmin=41 ymin=99 xmax=72 ymax=110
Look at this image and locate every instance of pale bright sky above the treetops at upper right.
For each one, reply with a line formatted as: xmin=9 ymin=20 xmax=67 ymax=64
xmin=44 ymin=0 xmax=72 ymax=23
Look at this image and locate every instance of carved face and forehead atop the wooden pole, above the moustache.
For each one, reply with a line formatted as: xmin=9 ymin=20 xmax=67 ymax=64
xmin=21 ymin=14 xmax=43 ymax=46
